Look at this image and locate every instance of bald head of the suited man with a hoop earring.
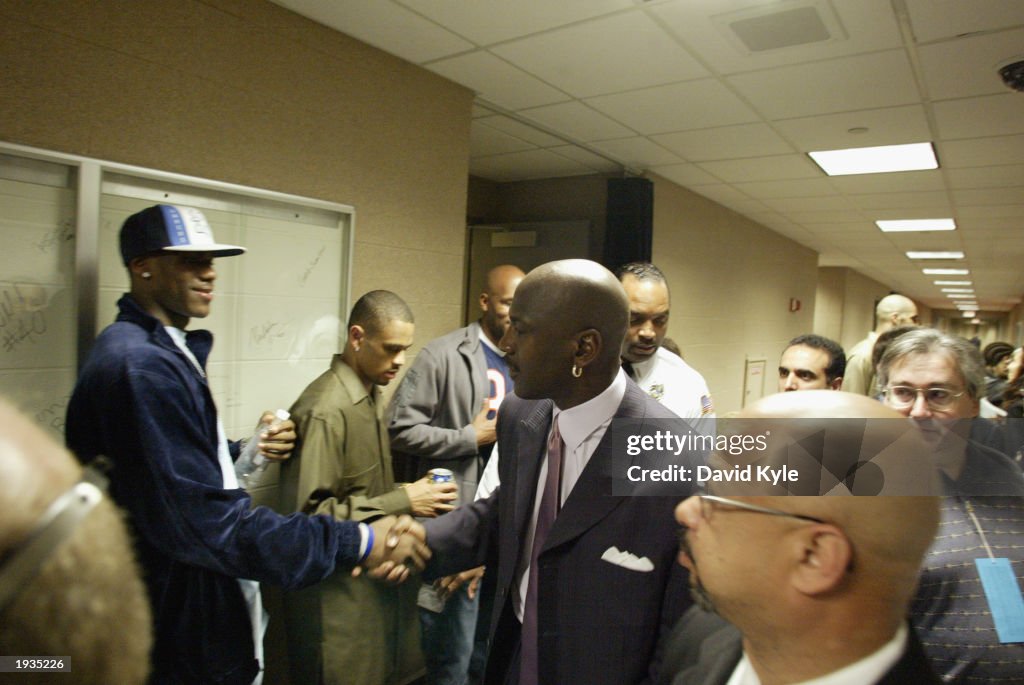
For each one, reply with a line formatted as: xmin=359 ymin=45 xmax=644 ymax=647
xmin=502 ymin=259 xmax=629 ymax=409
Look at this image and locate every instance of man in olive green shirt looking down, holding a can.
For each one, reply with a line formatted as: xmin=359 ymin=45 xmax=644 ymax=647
xmin=280 ymin=291 xmax=456 ymax=685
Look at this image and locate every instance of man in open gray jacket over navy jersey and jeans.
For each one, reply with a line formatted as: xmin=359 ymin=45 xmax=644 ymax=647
xmin=388 ymin=264 xmax=524 ymax=685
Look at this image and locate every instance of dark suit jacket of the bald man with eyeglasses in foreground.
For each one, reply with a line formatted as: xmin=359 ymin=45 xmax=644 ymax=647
xmin=657 ymin=607 xmax=942 ymax=685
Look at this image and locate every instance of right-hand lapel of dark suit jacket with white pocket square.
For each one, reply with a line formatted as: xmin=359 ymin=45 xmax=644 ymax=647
xmin=534 ymin=383 xmax=645 ymax=550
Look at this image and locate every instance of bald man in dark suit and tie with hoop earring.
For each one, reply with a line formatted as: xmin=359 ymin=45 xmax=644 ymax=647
xmin=427 ymin=259 xmax=686 ymax=685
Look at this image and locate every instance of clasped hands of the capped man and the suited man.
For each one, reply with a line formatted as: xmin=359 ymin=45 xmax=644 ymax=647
xmin=352 ymin=514 xmax=431 ymax=584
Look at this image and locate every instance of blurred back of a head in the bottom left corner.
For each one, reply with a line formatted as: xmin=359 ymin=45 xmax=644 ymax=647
xmin=0 ymin=400 xmax=153 ymax=685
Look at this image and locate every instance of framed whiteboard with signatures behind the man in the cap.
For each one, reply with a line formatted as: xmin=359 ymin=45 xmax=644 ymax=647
xmin=0 ymin=143 xmax=354 ymax=475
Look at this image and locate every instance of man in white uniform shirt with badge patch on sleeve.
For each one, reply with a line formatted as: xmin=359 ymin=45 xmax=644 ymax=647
xmin=615 ymin=262 xmax=715 ymax=419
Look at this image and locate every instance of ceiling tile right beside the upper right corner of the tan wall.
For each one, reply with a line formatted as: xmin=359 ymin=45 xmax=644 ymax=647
xmin=427 ymin=51 xmax=569 ymax=110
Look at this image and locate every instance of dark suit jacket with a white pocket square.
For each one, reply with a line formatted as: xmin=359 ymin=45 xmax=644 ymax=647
xmin=426 ymin=381 xmax=690 ymax=685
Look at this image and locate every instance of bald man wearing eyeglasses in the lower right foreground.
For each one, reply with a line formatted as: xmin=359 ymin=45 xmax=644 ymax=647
xmin=658 ymin=390 xmax=941 ymax=685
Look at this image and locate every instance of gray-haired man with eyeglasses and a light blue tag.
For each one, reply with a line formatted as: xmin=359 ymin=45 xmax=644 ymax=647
xmin=879 ymin=329 xmax=1024 ymax=683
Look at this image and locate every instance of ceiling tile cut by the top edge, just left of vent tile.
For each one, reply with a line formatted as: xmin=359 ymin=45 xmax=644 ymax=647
xmin=397 ymin=0 xmax=636 ymax=45
